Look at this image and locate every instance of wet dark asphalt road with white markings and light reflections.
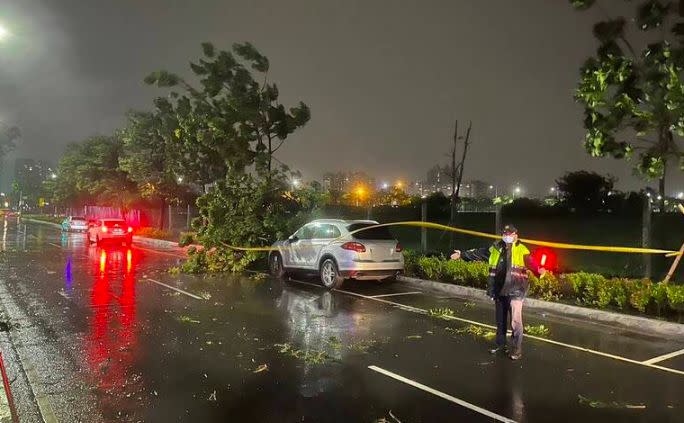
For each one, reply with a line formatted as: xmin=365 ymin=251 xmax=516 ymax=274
xmin=0 ymin=220 xmax=684 ymax=423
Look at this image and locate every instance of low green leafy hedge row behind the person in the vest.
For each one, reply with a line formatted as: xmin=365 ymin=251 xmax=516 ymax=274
xmin=404 ymin=252 xmax=684 ymax=315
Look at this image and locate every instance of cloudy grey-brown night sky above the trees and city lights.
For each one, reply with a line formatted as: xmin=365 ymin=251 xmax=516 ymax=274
xmin=0 ymin=0 xmax=684 ymax=194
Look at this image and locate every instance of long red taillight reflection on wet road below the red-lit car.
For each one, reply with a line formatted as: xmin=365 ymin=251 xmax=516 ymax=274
xmin=85 ymin=249 xmax=142 ymax=413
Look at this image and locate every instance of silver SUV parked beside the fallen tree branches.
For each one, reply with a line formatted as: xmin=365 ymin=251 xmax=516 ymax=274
xmin=269 ymin=219 xmax=404 ymax=289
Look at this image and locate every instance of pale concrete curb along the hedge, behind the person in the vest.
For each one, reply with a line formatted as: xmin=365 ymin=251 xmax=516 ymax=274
xmin=397 ymin=276 xmax=684 ymax=337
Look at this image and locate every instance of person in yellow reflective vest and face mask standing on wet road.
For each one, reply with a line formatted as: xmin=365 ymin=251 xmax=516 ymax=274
xmin=487 ymin=225 xmax=545 ymax=360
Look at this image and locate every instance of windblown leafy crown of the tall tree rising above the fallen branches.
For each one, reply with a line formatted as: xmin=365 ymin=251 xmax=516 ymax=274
xmin=145 ymin=43 xmax=310 ymax=184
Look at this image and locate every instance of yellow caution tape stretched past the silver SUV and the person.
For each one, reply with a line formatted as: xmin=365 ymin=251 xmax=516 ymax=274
xmin=218 ymin=221 xmax=680 ymax=257
